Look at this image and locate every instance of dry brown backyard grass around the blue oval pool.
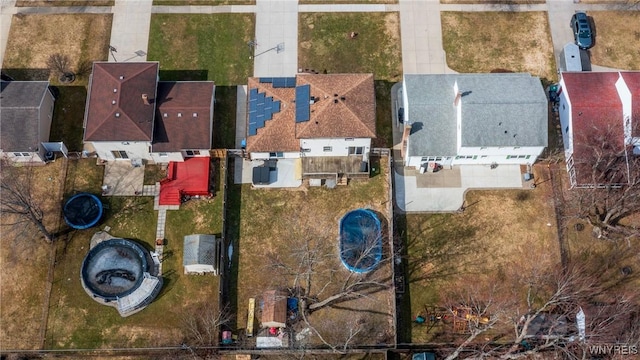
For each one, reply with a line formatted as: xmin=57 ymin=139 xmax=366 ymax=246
xmin=236 ymin=157 xmax=393 ymax=344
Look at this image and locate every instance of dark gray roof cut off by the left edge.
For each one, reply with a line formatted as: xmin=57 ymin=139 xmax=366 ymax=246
xmin=0 ymin=81 xmax=49 ymax=152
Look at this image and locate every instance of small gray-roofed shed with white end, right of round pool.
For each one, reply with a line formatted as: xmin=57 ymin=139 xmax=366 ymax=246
xmin=182 ymin=234 xmax=221 ymax=275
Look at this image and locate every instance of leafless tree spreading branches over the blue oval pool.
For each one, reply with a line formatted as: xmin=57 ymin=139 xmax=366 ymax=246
xmin=266 ymin=212 xmax=391 ymax=353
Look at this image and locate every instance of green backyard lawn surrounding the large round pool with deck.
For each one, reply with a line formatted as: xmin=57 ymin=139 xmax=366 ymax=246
xmin=46 ymin=159 xmax=222 ymax=348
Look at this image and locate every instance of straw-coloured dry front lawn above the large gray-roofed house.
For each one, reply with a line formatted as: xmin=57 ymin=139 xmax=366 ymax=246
xmin=441 ymin=12 xmax=557 ymax=82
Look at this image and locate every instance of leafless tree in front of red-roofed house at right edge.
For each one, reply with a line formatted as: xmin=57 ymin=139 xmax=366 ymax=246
xmin=567 ymin=116 xmax=640 ymax=239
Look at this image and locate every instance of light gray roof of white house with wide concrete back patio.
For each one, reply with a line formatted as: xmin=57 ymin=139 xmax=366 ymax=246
xmin=404 ymin=73 xmax=547 ymax=156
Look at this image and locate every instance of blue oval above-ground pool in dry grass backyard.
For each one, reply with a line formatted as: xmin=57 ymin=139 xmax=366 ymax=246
xmin=340 ymin=209 xmax=382 ymax=273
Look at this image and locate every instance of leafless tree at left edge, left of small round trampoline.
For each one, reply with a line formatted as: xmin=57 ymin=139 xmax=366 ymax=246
xmin=0 ymin=163 xmax=55 ymax=243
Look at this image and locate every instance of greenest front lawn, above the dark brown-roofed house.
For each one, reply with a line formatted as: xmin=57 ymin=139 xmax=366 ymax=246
xmin=147 ymin=14 xmax=255 ymax=86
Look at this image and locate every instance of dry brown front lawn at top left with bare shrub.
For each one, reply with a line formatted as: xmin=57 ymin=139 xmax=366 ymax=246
xmin=2 ymin=14 xmax=112 ymax=80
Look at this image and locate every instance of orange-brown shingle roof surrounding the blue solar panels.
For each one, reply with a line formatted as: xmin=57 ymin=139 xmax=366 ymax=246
xmin=247 ymin=74 xmax=376 ymax=152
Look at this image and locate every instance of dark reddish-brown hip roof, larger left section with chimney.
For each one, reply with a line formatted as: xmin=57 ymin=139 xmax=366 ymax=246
xmin=84 ymin=62 xmax=159 ymax=141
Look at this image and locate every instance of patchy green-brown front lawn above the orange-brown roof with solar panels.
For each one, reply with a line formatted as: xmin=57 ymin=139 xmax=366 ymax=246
xmin=298 ymin=13 xmax=402 ymax=81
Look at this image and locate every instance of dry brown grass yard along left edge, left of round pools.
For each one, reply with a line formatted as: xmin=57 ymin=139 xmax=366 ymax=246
xmin=0 ymin=161 xmax=64 ymax=349
